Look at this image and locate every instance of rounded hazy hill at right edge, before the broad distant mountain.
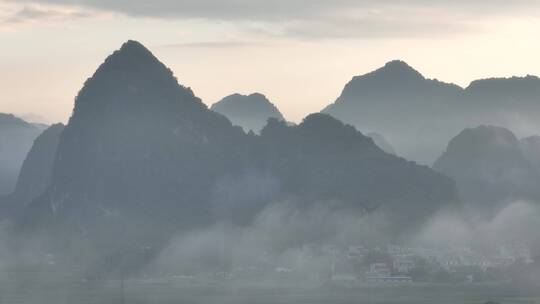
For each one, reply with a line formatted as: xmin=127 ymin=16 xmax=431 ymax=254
xmin=433 ymin=126 xmax=540 ymax=207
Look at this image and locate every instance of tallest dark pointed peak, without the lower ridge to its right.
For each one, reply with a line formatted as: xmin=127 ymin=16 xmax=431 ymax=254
xmin=29 ymin=41 xmax=244 ymax=225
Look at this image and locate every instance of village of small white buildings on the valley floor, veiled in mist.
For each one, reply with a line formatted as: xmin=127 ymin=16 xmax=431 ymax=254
xmin=226 ymin=242 xmax=533 ymax=284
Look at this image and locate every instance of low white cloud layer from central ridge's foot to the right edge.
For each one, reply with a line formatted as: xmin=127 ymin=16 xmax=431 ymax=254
xmin=142 ymin=201 xmax=540 ymax=274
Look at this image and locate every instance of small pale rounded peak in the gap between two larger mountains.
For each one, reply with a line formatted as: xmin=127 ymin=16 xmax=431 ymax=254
xmin=211 ymin=93 xmax=285 ymax=133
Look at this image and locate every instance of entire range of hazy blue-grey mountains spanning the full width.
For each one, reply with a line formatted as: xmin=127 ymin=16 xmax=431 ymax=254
xmin=0 ymin=41 xmax=540 ymax=276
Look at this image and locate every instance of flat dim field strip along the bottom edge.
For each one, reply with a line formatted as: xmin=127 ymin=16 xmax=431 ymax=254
xmin=0 ymin=273 xmax=540 ymax=304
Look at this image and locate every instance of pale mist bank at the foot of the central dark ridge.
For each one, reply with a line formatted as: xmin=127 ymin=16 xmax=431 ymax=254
xmin=148 ymin=201 xmax=388 ymax=273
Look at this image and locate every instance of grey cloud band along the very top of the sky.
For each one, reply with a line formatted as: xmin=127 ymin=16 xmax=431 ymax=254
xmin=6 ymin=0 xmax=538 ymax=20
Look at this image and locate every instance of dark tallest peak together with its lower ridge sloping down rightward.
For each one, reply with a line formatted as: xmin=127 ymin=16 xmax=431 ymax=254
xmin=16 ymin=41 xmax=457 ymax=274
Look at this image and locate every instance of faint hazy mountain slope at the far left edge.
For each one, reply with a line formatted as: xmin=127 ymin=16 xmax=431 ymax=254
xmin=0 ymin=113 xmax=41 ymax=195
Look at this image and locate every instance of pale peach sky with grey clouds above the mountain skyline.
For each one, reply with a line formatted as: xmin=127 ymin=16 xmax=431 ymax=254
xmin=0 ymin=0 xmax=540 ymax=123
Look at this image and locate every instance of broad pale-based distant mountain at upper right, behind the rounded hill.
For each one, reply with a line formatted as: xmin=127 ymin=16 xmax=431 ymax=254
xmin=322 ymin=61 xmax=540 ymax=164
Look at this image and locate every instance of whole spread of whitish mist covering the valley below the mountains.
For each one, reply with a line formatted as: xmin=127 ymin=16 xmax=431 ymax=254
xmin=0 ymin=195 xmax=540 ymax=303
